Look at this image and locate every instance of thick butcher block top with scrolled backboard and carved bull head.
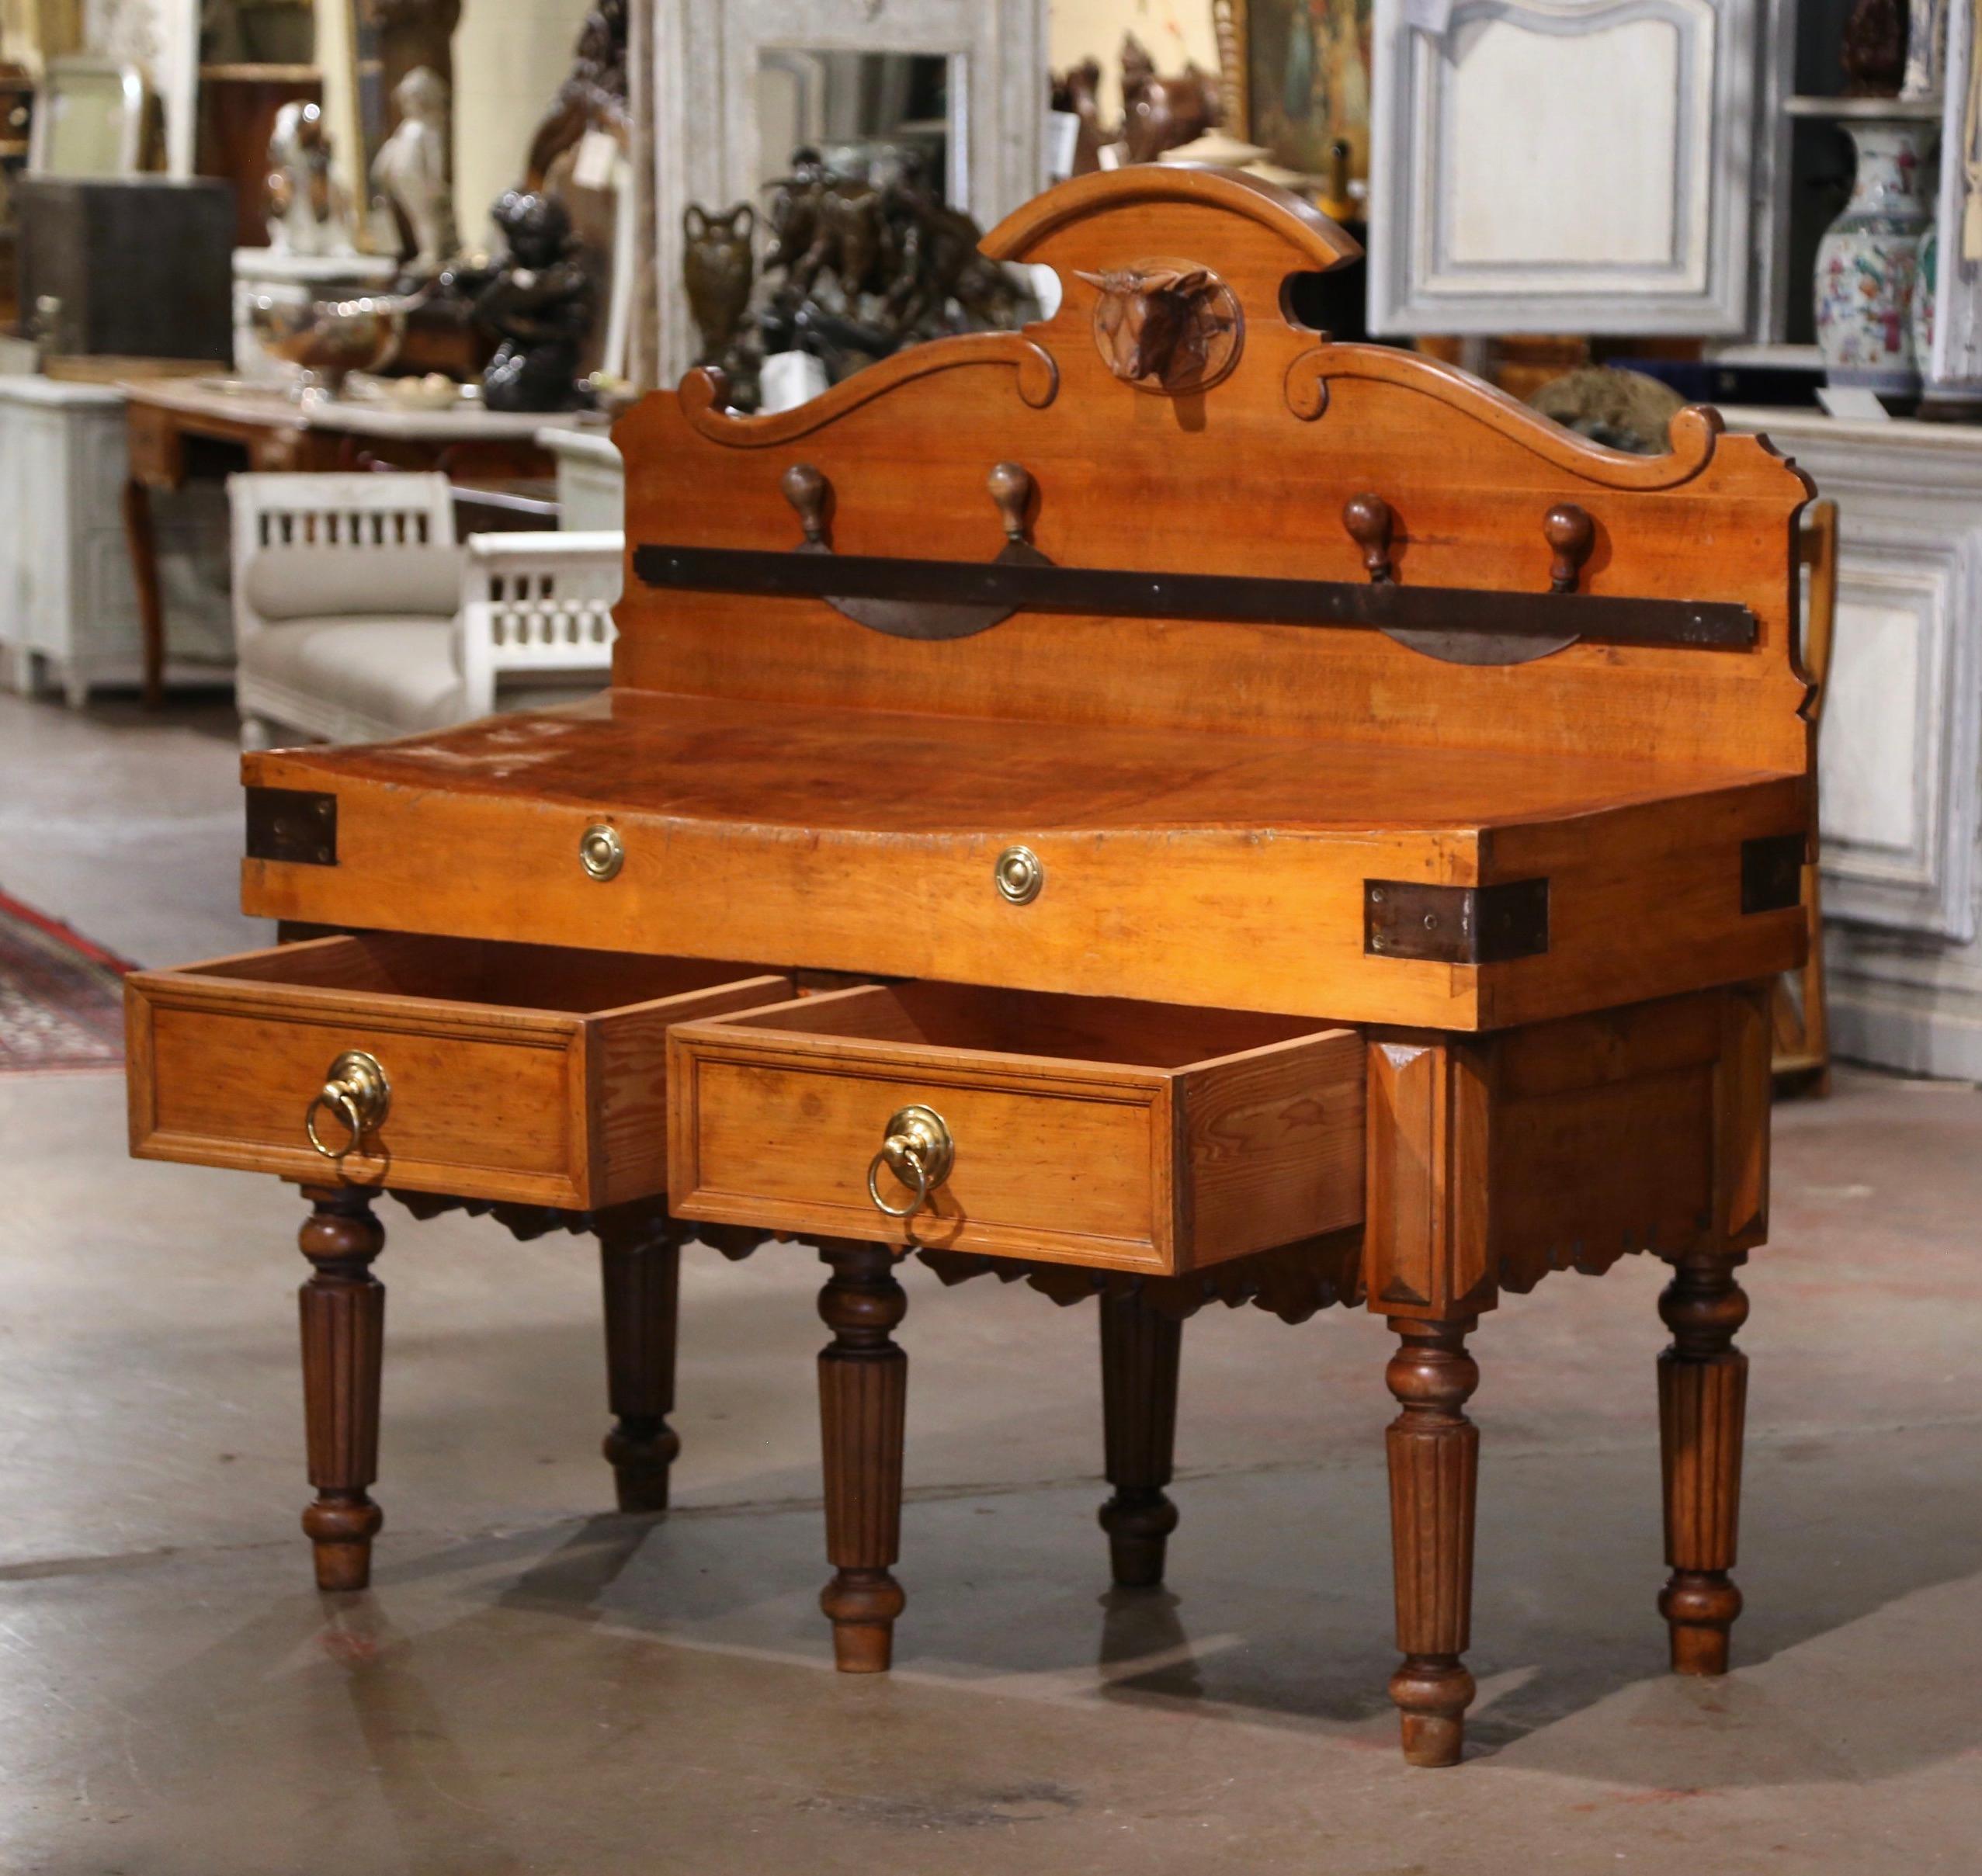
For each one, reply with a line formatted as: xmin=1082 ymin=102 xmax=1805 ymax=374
xmin=244 ymin=168 xmax=1810 ymax=1030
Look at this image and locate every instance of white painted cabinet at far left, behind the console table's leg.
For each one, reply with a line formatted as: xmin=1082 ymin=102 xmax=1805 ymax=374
xmin=0 ymin=376 xmax=234 ymax=707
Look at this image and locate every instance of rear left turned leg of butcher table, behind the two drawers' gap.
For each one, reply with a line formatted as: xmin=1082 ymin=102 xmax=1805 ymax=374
xmin=599 ymin=1215 xmax=682 ymax=1511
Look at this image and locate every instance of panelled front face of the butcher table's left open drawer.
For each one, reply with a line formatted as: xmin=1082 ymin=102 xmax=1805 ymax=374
xmin=133 ymin=1004 xmax=588 ymax=1206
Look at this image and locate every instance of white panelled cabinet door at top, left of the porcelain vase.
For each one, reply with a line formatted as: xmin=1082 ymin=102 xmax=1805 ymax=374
xmin=1369 ymin=0 xmax=1775 ymax=335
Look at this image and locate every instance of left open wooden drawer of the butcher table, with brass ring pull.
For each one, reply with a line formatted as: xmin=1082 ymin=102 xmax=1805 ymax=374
xmin=125 ymin=933 xmax=793 ymax=1210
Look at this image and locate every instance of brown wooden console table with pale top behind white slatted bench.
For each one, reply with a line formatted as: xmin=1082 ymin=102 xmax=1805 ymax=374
xmin=119 ymin=378 xmax=588 ymax=707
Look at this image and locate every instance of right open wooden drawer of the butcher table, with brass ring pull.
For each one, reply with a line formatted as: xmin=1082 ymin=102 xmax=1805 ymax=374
xmin=668 ymin=983 xmax=1363 ymax=1272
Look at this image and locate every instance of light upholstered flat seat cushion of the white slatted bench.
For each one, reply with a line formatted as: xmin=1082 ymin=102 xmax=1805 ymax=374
xmin=240 ymin=614 xmax=462 ymax=731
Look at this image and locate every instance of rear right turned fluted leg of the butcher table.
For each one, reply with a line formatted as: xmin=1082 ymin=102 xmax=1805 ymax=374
xmin=1659 ymin=1252 xmax=1748 ymax=1674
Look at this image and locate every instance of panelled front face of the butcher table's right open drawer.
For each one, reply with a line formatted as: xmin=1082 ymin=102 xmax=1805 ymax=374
xmin=670 ymin=1056 xmax=1175 ymax=1270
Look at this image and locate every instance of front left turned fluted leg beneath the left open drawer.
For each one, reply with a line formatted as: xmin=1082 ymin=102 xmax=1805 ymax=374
xmin=297 ymin=1187 xmax=384 ymax=1589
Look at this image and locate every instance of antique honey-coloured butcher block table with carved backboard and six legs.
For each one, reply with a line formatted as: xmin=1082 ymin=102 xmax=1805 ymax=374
xmin=129 ymin=166 xmax=1811 ymax=1765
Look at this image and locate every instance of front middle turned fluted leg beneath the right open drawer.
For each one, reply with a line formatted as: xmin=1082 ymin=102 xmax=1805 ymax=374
xmin=818 ymin=1242 xmax=908 ymax=1674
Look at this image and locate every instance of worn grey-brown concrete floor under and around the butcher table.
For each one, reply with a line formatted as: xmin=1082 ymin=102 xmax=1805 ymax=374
xmin=0 ymin=699 xmax=1982 ymax=1876
